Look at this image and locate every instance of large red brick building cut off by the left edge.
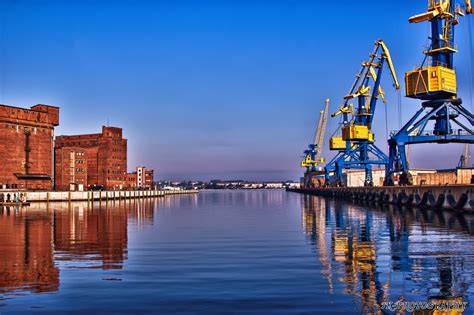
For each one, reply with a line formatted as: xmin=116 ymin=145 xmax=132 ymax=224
xmin=0 ymin=104 xmax=59 ymax=189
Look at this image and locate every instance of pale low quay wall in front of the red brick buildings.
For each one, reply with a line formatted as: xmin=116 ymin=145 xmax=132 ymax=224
xmin=0 ymin=190 xmax=198 ymax=202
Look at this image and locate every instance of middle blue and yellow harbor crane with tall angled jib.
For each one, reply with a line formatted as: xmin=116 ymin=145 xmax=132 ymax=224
xmin=325 ymin=39 xmax=400 ymax=186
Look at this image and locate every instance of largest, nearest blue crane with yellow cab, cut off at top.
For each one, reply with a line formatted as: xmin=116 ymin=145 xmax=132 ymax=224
xmin=385 ymin=0 xmax=474 ymax=186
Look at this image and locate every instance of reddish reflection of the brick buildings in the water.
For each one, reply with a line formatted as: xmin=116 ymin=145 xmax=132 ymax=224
xmin=0 ymin=199 xmax=156 ymax=293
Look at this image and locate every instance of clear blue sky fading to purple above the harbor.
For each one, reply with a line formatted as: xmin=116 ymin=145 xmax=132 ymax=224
xmin=0 ymin=0 xmax=474 ymax=180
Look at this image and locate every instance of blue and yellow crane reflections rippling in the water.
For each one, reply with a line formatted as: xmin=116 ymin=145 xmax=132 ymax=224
xmin=302 ymin=196 xmax=474 ymax=314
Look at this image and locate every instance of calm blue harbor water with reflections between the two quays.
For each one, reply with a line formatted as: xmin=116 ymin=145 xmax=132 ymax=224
xmin=0 ymin=191 xmax=474 ymax=315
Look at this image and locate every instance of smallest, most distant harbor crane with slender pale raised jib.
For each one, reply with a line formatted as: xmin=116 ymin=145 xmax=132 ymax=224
xmin=301 ymin=99 xmax=329 ymax=173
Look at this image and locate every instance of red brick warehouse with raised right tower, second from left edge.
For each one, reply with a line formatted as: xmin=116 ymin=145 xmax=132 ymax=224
xmin=54 ymin=126 xmax=127 ymax=190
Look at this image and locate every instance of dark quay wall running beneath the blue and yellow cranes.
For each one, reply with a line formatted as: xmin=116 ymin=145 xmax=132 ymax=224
xmin=288 ymin=185 xmax=474 ymax=212
